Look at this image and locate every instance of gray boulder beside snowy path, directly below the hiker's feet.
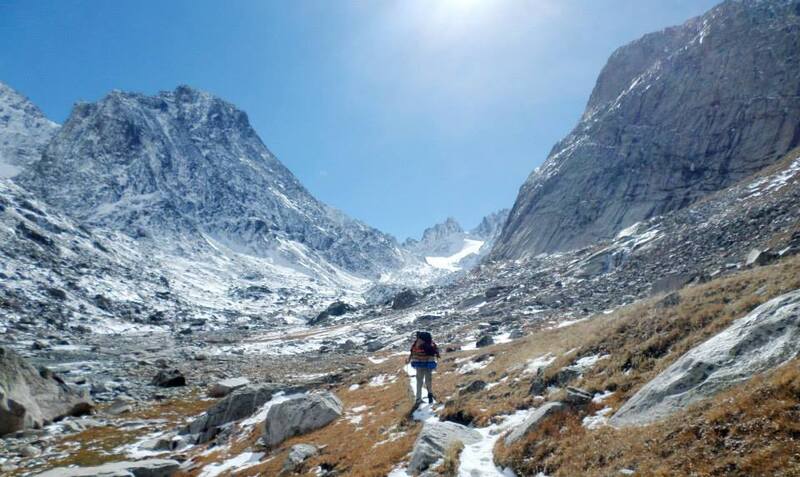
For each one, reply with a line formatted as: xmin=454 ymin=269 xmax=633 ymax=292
xmin=408 ymin=421 xmax=481 ymax=475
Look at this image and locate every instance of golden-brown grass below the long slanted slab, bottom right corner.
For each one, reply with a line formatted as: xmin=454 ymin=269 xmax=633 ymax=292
xmin=496 ymin=359 xmax=800 ymax=476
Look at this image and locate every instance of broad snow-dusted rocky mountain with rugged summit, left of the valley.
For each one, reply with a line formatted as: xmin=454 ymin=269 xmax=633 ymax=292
xmin=17 ymin=86 xmax=401 ymax=276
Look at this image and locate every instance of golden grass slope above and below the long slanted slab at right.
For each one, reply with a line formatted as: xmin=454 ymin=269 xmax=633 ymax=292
xmin=496 ymin=257 xmax=800 ymax=476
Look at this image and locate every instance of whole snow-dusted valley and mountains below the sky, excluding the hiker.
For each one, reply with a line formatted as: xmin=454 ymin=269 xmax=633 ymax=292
xmin=0 ymin=0 xmax=800 ymax=477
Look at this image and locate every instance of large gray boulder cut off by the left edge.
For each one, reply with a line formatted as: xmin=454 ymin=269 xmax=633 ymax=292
xmin=0 ymin=348 xmax=92 ymax=436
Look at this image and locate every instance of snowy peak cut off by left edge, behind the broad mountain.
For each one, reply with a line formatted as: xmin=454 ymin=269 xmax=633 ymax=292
xmin=0 ymin=82 xmax=58 ymax=178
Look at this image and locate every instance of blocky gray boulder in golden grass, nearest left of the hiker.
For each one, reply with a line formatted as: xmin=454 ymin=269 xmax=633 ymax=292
xmin=264 ymin=391 xmax=342 ymax=446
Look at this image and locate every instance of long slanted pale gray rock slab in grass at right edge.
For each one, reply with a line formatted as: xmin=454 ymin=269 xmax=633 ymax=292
xmin=609 ymin=290 xmax=800 ymax=426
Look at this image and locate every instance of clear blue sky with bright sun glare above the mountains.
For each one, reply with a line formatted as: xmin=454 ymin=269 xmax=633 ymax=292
xmin=0 ymin=0 xmax=717 ymax=240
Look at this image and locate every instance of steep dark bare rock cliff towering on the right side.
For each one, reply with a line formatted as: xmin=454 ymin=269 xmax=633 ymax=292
xmin=492 ymin=0 xmax=800 ymax=259
